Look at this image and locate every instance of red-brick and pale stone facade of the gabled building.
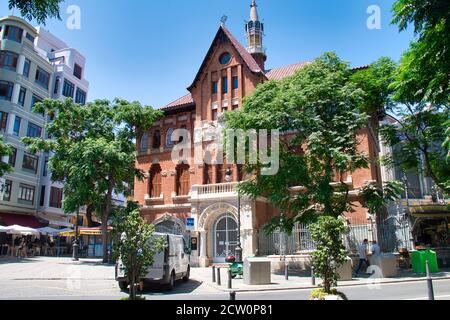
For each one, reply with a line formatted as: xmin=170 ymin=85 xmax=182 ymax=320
xmin=134 ymin=16 xmax=381 ymax=265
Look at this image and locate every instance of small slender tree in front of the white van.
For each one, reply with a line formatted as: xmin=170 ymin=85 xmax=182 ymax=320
xmin=113 ymin=205 xmax=166 ymax=300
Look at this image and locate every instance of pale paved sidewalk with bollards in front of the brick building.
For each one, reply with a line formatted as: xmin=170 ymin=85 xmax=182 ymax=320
xmin=191 ymin=268 xmax=450 ymax=292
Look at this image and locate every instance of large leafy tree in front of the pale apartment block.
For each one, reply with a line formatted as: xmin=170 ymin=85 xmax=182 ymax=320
xmin=22 ymin=99 xmax=162 ymax=262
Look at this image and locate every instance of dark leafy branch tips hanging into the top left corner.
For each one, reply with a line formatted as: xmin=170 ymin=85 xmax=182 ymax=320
xmin=8 ymin=0 xmax=64 ymax=25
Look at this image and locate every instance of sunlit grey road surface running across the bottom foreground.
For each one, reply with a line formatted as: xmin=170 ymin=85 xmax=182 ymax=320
xmin=0 ymin=258 xmax=450 ymax=301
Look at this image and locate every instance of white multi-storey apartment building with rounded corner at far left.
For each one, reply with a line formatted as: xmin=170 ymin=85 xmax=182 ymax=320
xmin=0 ymin=16 xmax=89 ymax=228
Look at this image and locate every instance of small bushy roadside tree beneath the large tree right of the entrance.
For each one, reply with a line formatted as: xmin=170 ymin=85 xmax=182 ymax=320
xmin=309 ymin=216 xmax=347 ymax=294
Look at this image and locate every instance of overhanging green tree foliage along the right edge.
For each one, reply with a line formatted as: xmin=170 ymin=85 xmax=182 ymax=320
xmin=382 ymin=0 xmax=450 ymax=195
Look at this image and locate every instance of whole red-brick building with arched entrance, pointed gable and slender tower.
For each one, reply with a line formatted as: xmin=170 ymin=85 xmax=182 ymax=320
xmin=134 ymin=1 xmax=380 ymax=266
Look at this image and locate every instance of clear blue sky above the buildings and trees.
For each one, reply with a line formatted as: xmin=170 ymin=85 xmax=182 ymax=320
xmin=0 ymin=0 xmax=413 ymax=108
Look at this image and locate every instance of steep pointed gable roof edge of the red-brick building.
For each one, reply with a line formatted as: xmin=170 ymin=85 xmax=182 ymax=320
xmin=188 ymin=26 xmax=267 ymax=91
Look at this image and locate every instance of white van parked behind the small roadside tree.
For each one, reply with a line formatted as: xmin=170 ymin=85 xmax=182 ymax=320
xmin=116 ymin=233 xmax=191 ymax=290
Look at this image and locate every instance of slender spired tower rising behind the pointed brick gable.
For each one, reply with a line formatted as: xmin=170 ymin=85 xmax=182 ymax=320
xmin=245 ymin=0 xmax=267 ymax=70
